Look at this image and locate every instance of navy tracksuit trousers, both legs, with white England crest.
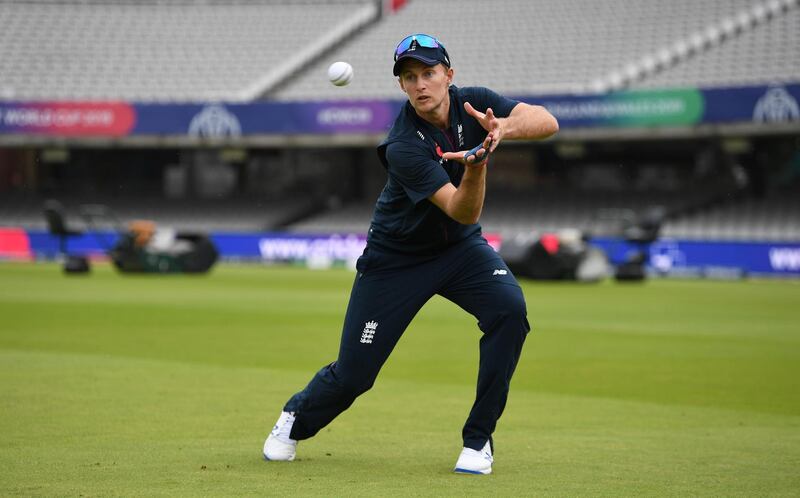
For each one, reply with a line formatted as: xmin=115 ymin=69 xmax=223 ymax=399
xmin=284 ymin=236 xmax=530 ymax=450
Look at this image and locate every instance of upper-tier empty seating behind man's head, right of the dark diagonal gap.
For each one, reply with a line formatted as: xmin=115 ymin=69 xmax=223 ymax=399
xmin=269 ymin=0 xmax=800 ymax=100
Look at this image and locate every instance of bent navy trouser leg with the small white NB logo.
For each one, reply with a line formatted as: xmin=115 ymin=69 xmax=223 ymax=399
xmin=440 ymin=239 xmax=530 ymax=450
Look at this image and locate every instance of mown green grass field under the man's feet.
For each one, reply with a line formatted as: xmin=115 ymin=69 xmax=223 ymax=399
xmin=0 ymin=263 xmax=800 ymax=497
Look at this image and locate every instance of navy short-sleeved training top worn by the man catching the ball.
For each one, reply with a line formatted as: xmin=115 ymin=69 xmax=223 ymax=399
xmin=367 ymin=85 xmax=519 ymax=255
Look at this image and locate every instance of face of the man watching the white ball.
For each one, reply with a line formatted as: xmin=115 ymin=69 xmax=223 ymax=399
xmin=399 ymin=59 xmax=453 ymax=114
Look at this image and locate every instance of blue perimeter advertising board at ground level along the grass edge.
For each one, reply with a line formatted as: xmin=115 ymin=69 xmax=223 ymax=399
xmin=10 ymin=229 xmax=800 ymax=277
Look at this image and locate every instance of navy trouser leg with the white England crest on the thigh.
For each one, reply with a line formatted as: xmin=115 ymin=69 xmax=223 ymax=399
xmin=284 ymin=249 xmax=433 ymax=440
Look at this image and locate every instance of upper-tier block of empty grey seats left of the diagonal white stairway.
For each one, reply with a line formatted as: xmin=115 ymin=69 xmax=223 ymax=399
xmin=0 ymin=0 xmax=378 ymax=101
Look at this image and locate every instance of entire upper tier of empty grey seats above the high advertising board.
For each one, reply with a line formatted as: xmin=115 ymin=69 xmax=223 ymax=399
xmin=0 ymin=0 xmax=800 ymax=101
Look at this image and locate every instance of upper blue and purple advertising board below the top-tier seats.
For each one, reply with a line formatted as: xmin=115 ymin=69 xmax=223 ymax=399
xmin=0 ymin=84 xmax=800 ymax=139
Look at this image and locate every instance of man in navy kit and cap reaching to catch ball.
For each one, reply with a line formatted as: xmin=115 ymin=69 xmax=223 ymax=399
xmin=264 ymin=34 xmax=558 ymax=474
